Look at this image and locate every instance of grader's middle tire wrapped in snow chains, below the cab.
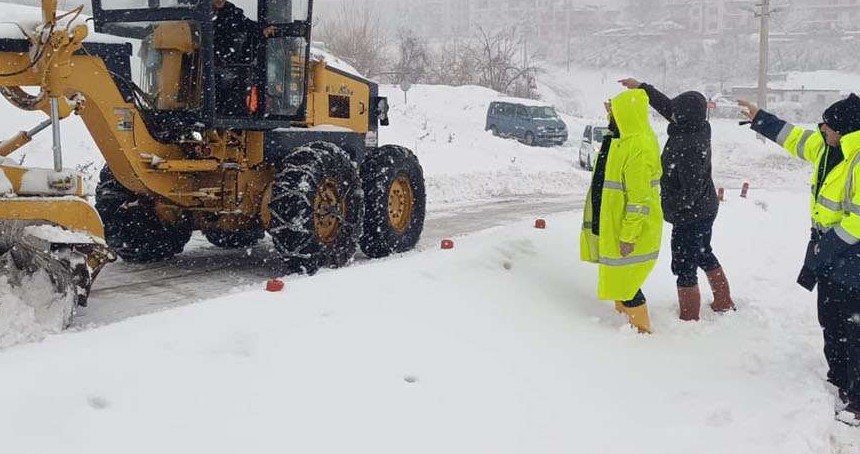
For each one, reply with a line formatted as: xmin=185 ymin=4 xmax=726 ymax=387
xmin=269 ymin=142 xmax=364 ymax=274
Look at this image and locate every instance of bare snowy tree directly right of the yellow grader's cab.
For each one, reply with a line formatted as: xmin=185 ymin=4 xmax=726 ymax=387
xmin=320 ymin=0 xmax=388 ymax=77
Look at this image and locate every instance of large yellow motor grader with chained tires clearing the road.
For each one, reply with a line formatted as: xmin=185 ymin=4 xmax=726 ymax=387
xmin=0 ymin=0 xmax=425 ymax=323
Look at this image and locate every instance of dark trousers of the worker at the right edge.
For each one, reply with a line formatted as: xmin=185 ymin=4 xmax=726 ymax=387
xmin=818 ymin=277 xmax=860 ymax=404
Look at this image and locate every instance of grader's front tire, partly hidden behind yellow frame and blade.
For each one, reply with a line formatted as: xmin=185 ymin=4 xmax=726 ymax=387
xmin=96 ymin=166 xmax=191 ymax=263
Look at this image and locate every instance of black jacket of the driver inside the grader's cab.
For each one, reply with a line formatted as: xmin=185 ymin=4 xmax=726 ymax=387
xmin=213 ymin=2 xmax=263 ymax=66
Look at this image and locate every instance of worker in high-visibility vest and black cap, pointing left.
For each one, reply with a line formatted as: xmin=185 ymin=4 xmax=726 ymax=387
xmin=740 ymin=94 xmax=860 ymax=425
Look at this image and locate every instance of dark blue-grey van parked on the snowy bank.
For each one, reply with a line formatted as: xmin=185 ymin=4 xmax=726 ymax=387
xmin=485 ymin=101 xmax=568 ymax=146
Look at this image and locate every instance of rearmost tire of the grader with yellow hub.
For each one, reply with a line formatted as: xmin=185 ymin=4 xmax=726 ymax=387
xmin=361 ymin=145 xmax=427 ymax=258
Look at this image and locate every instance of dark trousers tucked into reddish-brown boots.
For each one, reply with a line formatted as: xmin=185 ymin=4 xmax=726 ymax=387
xmin=672 ymin=218 xmax=720 ymax=287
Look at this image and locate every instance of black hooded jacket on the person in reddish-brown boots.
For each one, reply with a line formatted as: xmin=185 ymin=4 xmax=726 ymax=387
xmin=641 ymin=84 xmax=720 ymax=224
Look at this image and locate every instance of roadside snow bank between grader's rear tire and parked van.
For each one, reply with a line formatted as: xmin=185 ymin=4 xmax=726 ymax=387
xmin=380 ymin=85 xmax=590 ymax=204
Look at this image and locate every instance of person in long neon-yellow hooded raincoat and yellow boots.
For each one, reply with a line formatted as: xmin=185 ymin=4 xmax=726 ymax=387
xmin=580 ymin=89 xmax=663 ymax=333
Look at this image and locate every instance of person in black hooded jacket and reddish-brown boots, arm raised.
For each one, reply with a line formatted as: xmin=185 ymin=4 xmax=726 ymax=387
xmin=620 ymin=79 xmax=735 ymax=320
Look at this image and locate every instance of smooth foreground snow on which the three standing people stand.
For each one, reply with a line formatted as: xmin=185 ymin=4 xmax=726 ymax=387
xmin=0 ymin=191 xmax=860 ymax=454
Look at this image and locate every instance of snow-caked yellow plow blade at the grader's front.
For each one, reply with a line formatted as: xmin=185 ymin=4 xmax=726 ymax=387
xmin=0 ymin=197 xmax=116 ymax=329
